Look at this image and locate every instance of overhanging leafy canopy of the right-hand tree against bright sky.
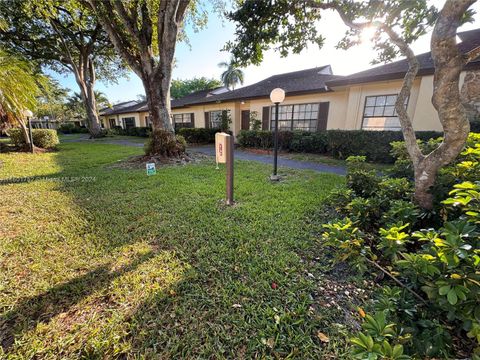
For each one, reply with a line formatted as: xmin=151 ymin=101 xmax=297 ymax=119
xmin=225 ymin=0 xmax=438 ymax=65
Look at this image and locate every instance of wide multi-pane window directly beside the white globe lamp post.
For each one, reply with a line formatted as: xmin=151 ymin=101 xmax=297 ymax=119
xmin=270 ymin=104 xmax=319 ymax=131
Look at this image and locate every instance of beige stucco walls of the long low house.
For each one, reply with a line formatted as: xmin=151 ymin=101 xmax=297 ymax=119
xmin=102 ymin=69 xmax=476 ymax=136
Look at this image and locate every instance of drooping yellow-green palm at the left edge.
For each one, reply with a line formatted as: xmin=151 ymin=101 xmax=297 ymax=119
xmin=0 ymin=49 xmax=43 ymax=147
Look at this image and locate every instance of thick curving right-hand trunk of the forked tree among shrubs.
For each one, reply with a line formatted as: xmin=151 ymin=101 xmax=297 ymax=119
xmin=412 ymin=0 xmax=473 ymax=209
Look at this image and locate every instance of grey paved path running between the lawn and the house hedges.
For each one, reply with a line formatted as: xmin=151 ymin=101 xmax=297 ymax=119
xmin=62 ymin=135 xmax=346 ymax=175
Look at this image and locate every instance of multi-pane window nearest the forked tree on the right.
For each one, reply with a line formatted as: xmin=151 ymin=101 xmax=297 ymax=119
xmin=362 ymin=95 xmax=408 ymax=130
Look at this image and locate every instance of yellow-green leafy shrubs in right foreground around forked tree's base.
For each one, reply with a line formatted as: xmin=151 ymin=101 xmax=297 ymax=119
xmin=322 ymin=133 xmax=480 ymax=359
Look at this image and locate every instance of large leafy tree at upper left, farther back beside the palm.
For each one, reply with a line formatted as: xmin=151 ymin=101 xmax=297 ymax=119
xmin=0 ymin=0 xmax=123 ymax=137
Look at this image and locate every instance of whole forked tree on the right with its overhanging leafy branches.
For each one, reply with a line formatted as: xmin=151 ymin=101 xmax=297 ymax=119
xmin=227 ymin=0 xmax=480 ymax=209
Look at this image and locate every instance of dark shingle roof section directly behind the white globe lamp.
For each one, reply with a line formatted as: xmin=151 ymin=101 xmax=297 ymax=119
xmin=178 ymin=65 xmax=341 ymax=107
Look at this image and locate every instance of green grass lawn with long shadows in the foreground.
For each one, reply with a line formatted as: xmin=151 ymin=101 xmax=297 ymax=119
xmin=0 ymin=143 xmax=356 ymax=359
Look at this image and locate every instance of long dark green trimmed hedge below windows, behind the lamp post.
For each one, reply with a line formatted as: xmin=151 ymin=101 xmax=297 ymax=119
xmin=238 ymin=130 xmax=442 ymax=163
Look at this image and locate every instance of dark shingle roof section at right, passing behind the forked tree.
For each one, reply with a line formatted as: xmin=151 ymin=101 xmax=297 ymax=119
xmin=327 ymin=29 xmax=480 ymax=86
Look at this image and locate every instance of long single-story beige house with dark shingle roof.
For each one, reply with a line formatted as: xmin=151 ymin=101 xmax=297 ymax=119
xmin=101 ymin=29 xmax=480 ymax=135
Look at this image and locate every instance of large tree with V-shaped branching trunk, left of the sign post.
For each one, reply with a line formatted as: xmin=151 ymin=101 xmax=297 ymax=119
xmin=85 ymin=0 xmax=190 ymax=149
